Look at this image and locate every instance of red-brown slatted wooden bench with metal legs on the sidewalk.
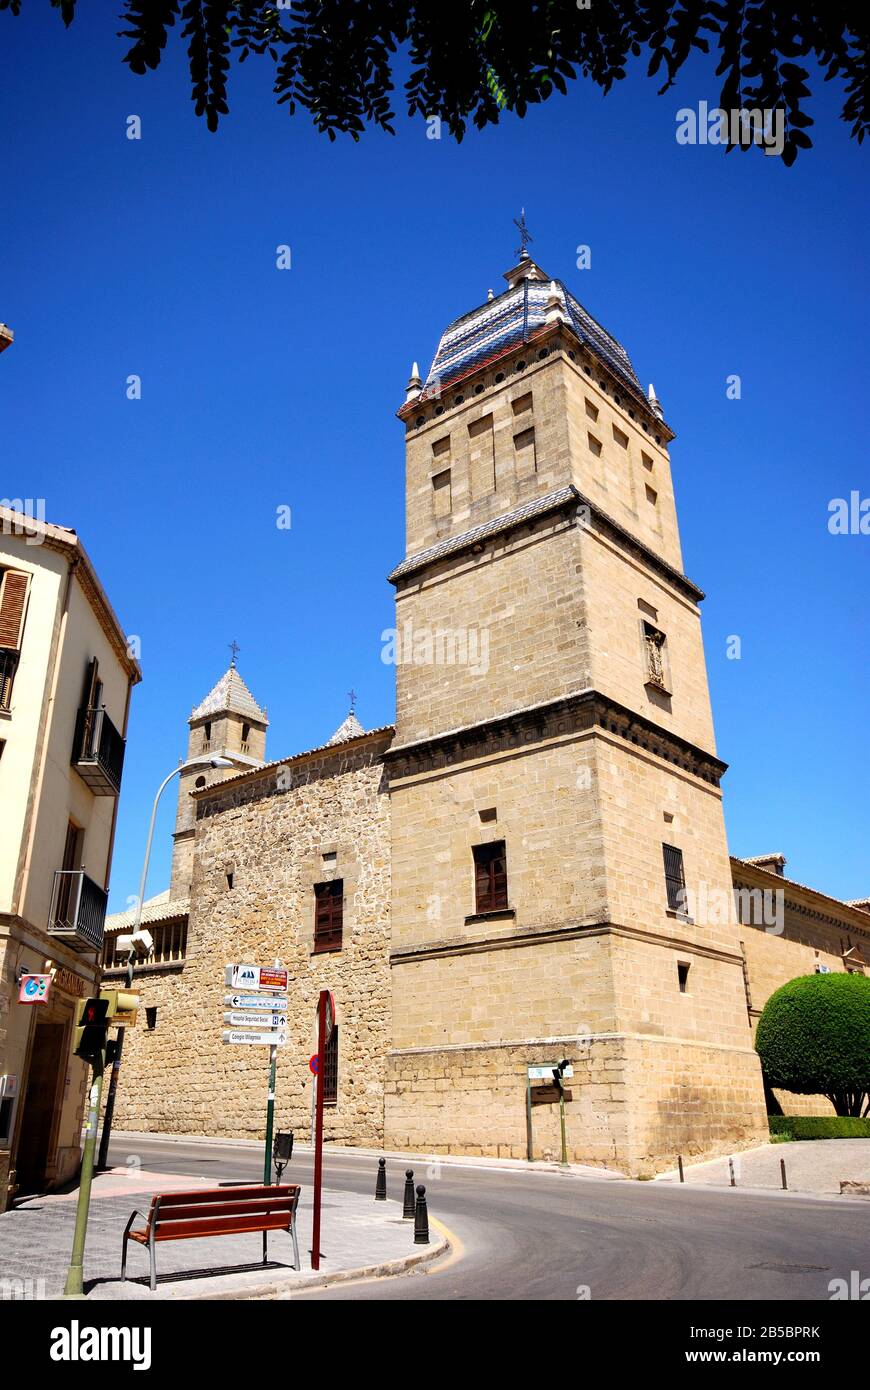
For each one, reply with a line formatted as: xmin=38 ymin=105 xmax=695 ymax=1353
xmin=121 ymin=1183 xmax=302 ymax=1293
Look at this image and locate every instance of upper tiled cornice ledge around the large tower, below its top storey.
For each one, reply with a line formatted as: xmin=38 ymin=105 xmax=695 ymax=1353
xmin=388 ymin=482 xmax=705 ymax=603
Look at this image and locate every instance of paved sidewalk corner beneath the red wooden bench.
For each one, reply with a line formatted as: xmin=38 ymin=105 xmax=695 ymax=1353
xmin=0 ymin=1169 xmax=448 ymax=1301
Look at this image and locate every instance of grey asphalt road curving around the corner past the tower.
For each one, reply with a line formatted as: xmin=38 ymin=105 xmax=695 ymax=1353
xmin=110 ymin=1136 xmax=870 ymax=1301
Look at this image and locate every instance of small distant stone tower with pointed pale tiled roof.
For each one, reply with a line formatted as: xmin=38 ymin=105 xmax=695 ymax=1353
xmin=170 ymin=656 xmax=268 ymax=899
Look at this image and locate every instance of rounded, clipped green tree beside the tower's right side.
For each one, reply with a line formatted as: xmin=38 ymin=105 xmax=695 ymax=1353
xmin=755 ymin=973 xmax=870 ymax=1115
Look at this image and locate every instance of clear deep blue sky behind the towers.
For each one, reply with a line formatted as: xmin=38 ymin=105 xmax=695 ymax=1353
xmin=0 ymin=4 xmax=870 ymax=909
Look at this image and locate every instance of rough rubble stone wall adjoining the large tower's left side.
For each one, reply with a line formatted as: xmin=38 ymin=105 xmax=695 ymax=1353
xmin=108 ymin=735 xmax=391 ymax=1144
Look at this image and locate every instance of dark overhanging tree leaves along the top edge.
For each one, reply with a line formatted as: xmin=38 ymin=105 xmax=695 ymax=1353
xmin=0 ymin=0 xmax=870 ymax=164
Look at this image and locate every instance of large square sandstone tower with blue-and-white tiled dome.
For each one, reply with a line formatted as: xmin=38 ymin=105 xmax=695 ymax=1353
xmin=385 ymin=253 xmax=766 ymax=1172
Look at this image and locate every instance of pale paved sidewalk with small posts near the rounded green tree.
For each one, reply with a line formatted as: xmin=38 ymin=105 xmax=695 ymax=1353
xmin=655 ymin=1138 xmax=870 ymax=1195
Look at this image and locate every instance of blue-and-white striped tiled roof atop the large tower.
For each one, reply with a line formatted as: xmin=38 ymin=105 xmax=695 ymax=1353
xmin=422 ymin=278 xmax=645 ymax=399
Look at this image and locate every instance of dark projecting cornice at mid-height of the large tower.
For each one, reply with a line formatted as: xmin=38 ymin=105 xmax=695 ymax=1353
xmin=384 ymin=689 xmax=727 ymax=787
